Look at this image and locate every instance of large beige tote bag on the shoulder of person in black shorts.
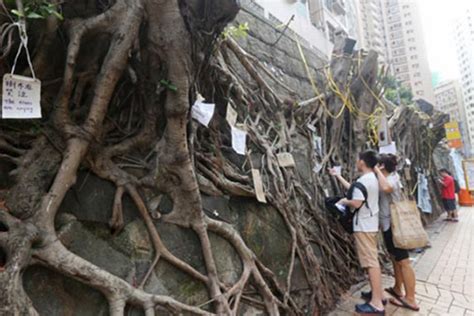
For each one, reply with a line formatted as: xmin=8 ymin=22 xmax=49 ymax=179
xmin=390 ymin=200 xmax=428 ymax=249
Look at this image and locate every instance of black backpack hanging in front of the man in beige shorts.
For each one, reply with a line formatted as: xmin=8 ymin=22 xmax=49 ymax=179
xmin=325 ymin=182 xmax=370 ymax=234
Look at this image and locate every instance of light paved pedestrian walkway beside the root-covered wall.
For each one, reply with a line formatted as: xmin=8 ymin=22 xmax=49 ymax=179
xmin=329 ymin=208 xmax=474 ymax=316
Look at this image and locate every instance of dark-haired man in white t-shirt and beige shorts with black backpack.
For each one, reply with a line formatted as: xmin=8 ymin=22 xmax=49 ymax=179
xmin=330 ymin=150 xmax=385 ymax=315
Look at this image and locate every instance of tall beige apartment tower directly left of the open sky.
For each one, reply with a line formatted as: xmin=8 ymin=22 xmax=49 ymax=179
xmin=384 ymin=0 xmax=435 ymax=104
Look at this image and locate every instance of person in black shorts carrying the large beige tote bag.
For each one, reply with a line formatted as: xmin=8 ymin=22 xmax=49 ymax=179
xmin=372 ymin=154 xmax=420 ymax=312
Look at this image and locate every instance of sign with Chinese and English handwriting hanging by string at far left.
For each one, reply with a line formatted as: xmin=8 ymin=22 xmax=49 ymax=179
xmin=2 ymin=74 xmax=41 ymax=119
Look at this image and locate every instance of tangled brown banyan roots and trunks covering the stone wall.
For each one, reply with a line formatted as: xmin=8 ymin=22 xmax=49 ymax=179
xmin=0 ymin=0 xmax=448 ymax=316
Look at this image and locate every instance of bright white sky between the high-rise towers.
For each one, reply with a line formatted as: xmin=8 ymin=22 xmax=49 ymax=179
xmin=418 ymin=0 xmax=474 ymax=80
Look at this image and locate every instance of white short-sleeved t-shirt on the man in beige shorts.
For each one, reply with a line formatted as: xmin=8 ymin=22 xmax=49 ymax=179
xmin=352 ymin=172 xmax=379 ymax=233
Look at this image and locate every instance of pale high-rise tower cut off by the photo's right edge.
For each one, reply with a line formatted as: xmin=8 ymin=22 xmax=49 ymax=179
xmin=454 ymin=9 xmax=474 ymax=149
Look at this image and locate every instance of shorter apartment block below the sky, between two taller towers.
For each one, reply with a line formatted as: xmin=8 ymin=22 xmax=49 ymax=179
xmin=434 ymin=80 xmax=471 ymax=153
